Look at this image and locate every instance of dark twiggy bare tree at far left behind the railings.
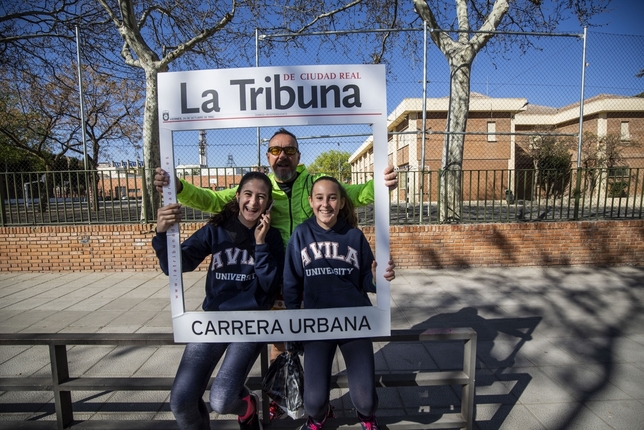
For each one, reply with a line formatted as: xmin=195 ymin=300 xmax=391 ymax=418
xmin=0 ymin=66 xmax=141 ymax=169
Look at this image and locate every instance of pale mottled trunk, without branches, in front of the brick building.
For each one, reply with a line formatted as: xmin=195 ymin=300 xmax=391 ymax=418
xmin=440 ymin=45 xmax=474 ymax=223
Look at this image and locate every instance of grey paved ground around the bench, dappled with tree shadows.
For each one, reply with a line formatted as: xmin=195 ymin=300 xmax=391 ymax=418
xmin=0 ymin=267 xmax=644 ymax=430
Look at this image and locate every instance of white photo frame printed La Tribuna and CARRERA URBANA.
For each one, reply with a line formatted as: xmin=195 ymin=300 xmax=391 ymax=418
xmin=158 ymin=65 xmax=391 ymax=342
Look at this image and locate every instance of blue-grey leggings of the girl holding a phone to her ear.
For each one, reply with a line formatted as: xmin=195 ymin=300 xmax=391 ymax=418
xmin=170 ymin=343 xmax=266 ymax=430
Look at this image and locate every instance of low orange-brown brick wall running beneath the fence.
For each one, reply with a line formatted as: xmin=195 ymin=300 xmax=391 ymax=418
xmin=0 ymin=220 xmax=644 ymax=271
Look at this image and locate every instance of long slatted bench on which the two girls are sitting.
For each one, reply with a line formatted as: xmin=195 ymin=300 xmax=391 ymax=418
xmin=0 ymin=328 xmax=476 ymax=430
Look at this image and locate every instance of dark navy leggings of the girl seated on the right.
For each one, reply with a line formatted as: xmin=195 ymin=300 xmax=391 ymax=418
xmin=304 ymin=339 xmax=378 ymax=422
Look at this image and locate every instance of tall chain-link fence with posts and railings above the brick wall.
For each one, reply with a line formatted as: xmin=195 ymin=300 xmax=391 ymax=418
xmin=0 ymin=30 xmax=644 ymax=225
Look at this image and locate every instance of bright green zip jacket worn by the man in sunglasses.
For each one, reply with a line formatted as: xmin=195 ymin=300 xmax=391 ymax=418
xmin=177 ymin=164 xmax=374 ymax=246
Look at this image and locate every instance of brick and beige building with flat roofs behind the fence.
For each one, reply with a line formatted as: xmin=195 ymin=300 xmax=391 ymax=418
xmin=349 ymin=93 xmax=644 ymax=198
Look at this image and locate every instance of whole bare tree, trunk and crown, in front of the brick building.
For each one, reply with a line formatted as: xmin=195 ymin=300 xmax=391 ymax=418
xmin=413 ymin=0 xmax=608 ymax=222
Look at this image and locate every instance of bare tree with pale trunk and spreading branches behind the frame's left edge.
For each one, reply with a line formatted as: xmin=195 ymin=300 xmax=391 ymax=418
xmin=0 ymin=0 xmax=397 ymax=220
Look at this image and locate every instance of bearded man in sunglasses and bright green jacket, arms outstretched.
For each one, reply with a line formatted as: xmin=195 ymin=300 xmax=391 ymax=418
xmin=154 ymin=128 xmax=398 ymax=246
